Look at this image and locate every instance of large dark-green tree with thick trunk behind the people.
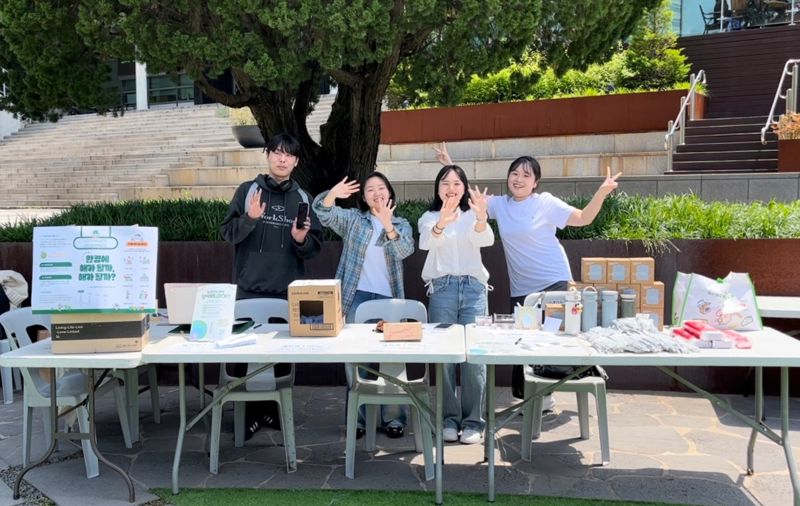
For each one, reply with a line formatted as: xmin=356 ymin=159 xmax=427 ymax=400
xmin=0 ymin=0 xmax=658 ymax=192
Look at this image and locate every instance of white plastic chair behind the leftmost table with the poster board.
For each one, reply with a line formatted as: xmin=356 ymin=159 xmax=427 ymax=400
xmin=0 ymin=307 xmax=131 ymax=478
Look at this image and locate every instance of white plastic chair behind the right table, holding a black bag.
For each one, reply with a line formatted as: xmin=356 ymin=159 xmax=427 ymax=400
xmin=521 ymin=292 xmax=611 ymax=465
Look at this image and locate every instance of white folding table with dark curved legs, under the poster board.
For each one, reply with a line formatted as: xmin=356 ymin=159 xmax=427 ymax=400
xmin=0 ymin=339 xmax=142 ymax=502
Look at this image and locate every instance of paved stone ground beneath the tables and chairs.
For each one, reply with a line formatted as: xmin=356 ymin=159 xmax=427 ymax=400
xmin=0 ymin=386 xmax=800 ymax=506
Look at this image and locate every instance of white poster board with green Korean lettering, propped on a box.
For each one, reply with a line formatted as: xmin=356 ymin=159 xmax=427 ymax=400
xmin=31 ymin=226 xmax=158 ymax=313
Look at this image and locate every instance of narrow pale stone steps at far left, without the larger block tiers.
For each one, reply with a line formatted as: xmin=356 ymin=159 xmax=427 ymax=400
xmin=0 ymin=106 xmax=238 ymax=208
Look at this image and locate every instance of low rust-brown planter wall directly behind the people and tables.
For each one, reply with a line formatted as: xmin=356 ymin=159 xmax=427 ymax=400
xmin=0 ymin=239 xmax=800 ymax=392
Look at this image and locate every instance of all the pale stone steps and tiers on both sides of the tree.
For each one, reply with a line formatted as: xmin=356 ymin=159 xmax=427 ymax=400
xmin=0 ymin=96 xmax=666 ymax=208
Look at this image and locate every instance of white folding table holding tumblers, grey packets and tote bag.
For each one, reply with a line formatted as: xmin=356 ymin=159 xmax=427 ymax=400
xmin=466 ymin=325 xmax=800 ymax=506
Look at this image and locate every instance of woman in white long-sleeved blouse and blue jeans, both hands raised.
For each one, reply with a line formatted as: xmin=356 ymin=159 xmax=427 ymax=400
xmin=418 ymin=165 xmax=494 ymax=444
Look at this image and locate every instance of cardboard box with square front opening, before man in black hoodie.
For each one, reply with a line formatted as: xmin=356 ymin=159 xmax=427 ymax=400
xmin=288 ymin=279 xmax=344 ymax=337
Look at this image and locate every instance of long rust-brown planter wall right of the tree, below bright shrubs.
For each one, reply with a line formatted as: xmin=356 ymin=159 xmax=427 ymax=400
xmin=381 ymin=90 xmax=705 ymax=144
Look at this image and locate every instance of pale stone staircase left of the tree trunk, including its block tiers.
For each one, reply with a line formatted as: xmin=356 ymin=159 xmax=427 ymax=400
xmin=0 ymin=95 xmax=333 ymax=208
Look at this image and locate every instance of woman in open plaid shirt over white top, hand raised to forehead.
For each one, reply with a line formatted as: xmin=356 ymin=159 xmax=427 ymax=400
xmin=313 ymin=172 xmax=414 ymax=438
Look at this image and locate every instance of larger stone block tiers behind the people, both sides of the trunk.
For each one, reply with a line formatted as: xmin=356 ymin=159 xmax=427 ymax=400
xmin=123 ymin=132 xmax=666 ymax=200
